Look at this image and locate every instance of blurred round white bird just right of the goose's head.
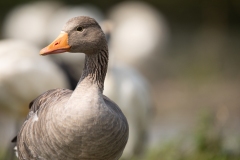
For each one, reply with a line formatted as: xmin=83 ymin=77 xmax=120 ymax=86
xmin=108 ymin=1 xmax=169 ymax=69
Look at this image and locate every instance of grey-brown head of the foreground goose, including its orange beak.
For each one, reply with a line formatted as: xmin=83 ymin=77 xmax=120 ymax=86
xmin=40 ymin=16 xmax=107 ymax=55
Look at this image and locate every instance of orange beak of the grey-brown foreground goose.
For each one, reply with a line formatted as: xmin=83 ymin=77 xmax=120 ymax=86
xmin=40 ymin=32 xmax=70 ymax=55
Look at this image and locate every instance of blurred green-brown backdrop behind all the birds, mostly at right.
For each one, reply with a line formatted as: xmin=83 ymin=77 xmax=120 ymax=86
xmin=0 ymin=0 xmax=240 ymax=160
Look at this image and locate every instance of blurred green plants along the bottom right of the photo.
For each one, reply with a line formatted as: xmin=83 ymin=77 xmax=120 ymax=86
xmin=125 ymin=110 xmax=240 ymax=160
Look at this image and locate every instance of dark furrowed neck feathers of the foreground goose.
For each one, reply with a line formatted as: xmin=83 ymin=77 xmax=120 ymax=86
xmin=80 ymin=47 xmax=108 ymax=92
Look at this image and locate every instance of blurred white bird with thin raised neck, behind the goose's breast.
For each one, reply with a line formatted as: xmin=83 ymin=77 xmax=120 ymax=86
xmin=102 ymin=21 xmax=152 ymax=159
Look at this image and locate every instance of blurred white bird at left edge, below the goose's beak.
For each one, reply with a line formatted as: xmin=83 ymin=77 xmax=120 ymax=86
xmin=0 ymin=40 xmax=69 ymax=156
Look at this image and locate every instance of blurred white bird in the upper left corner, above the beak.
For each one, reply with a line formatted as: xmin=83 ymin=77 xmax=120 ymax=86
xmin=2 ymin=1 xmax=61 ymax=48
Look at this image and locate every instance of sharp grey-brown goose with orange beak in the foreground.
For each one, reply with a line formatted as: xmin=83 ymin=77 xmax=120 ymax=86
xmin=13 ymin=16 xmax=129 ymax=160
